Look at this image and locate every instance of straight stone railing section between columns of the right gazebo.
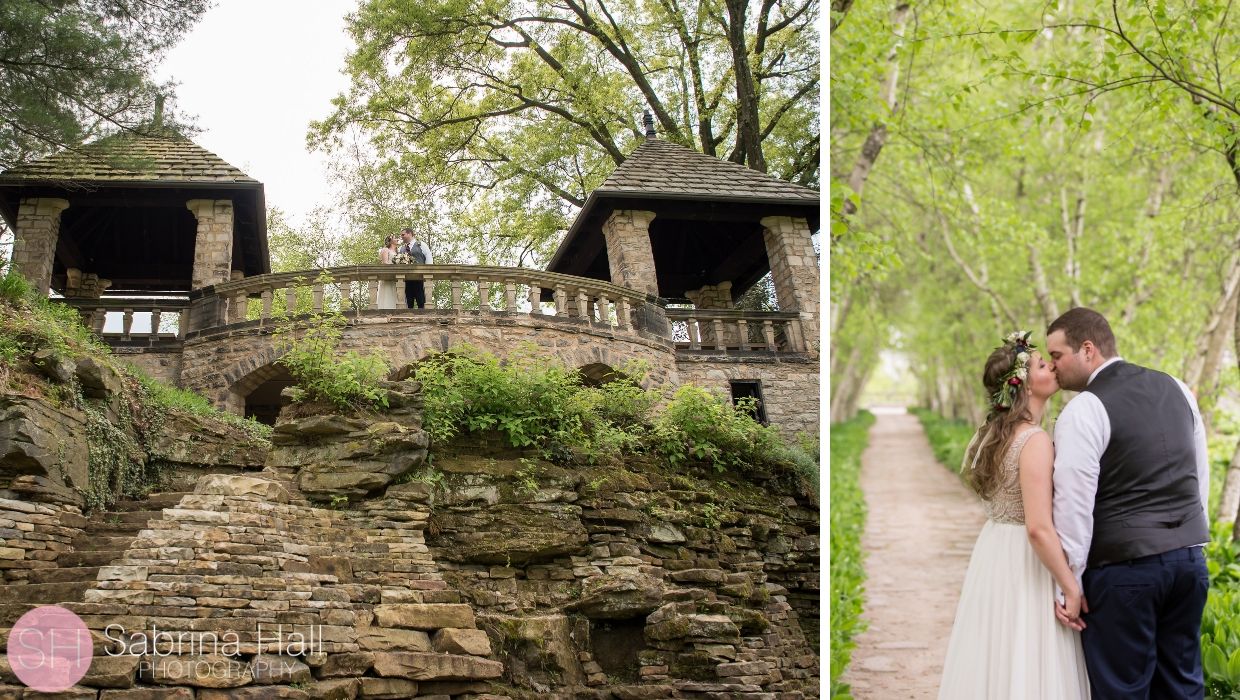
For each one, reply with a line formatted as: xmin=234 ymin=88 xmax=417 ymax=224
xmin=667 ymin=308 xmax=806 ymax=352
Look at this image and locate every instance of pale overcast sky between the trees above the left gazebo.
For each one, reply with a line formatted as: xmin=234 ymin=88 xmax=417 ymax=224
xmin=157 ymin=0 xmax=356 ymax=221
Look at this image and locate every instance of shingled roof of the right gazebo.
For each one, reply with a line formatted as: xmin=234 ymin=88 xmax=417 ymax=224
xmin=595 ymin=139 xmax=818 ymax=204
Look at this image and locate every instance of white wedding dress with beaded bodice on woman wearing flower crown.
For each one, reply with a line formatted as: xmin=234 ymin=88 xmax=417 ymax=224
xmin=939 ymin=427 xmax=1090 ymax=700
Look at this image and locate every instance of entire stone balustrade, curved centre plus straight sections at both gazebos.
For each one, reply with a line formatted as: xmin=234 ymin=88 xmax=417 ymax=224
xmin=61 ymin=265 xmax=807 ymax=354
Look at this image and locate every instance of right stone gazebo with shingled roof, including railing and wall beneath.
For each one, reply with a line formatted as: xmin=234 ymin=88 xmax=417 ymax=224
xmin=547 ymin=127 xmax=820 ymax=432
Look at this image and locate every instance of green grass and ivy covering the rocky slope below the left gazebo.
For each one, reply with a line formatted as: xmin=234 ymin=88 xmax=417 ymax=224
xmin=0 ymin=271 xmax=272 ymax=510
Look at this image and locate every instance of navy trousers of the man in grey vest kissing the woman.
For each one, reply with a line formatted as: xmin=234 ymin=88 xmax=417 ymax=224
xmin=1081 ymin=546 xmax=1210 ymax=700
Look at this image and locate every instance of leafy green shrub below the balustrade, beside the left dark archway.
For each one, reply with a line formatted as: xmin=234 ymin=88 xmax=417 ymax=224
xmin=272 ymin=301 xmax=389 ymax=411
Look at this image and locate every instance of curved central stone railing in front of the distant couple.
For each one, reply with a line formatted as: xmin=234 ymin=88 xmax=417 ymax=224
xmin=190 ymin=265 xmax=657 ymax=331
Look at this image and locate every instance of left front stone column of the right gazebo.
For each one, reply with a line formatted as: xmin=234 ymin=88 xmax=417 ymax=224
xmin=603 ymin=209 xmax=671 ymax=337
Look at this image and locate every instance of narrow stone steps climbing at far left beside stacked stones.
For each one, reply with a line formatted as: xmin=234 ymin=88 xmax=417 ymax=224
xmin=0 ymin=492 xmax=188 ymax=627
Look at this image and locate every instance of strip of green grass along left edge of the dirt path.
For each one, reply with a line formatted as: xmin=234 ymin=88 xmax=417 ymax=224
xmin=830 ymin=411 xmax=874 ymax=699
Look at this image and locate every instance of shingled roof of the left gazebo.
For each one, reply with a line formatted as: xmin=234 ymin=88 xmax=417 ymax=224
xmin=0 ymin=133 xmax=260 ymax=187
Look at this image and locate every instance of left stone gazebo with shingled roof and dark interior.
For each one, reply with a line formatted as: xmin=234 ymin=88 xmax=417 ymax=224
xmin=0 ymin=133 xmax=270 ymax=317
